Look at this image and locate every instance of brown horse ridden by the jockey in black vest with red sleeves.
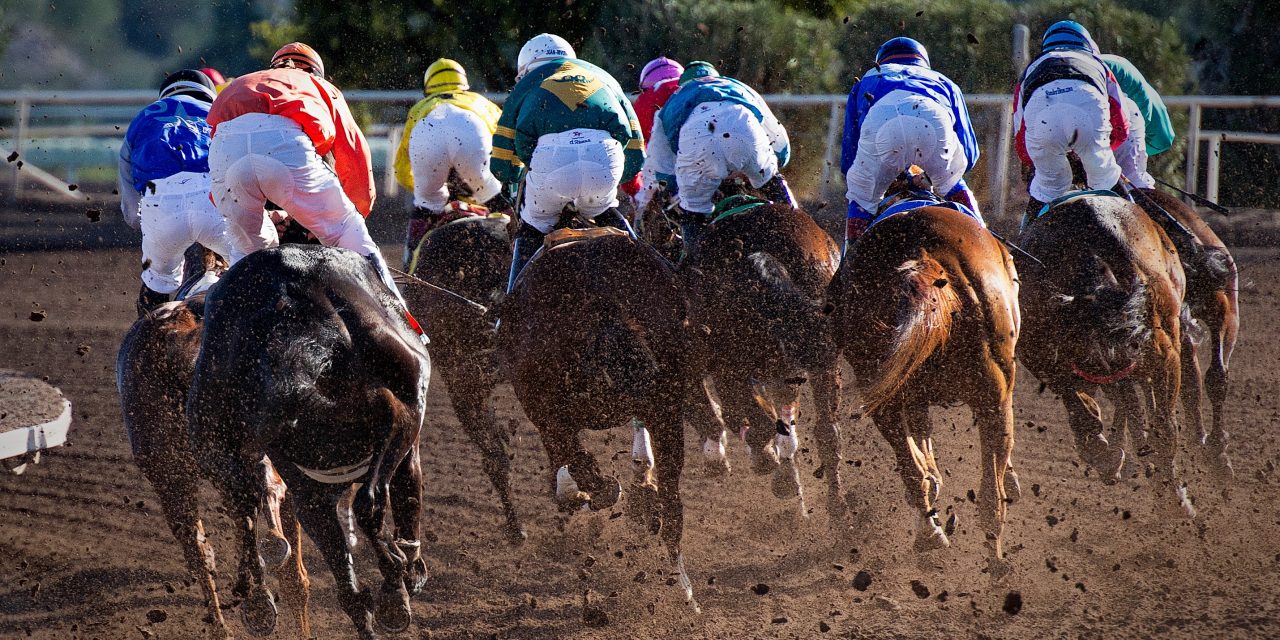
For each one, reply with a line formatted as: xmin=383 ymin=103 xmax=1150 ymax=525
xmin=1019 ymin=195 xmax=1194 ymax=515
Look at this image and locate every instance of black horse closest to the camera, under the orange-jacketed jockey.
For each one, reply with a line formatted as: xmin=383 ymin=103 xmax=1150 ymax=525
xmin=187 ymin=244 xmax=430 ymax=639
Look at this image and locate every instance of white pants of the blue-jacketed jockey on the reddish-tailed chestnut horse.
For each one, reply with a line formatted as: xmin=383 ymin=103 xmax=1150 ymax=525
xmin=845 ymin=91 xmax=969 ymax=212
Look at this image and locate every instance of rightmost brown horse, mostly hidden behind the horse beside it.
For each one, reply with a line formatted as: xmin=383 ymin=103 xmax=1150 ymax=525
xmin=1137 ymin=189 xmax=1240 ymax=476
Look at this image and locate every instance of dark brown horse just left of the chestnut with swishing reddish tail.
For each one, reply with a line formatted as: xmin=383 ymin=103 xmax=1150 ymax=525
xmin=680 ymin=196 xmax=846 ymax=521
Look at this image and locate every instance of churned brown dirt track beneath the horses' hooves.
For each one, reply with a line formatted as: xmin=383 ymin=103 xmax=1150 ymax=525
xmin=0 ymin=250 xmax=1280 ymax=640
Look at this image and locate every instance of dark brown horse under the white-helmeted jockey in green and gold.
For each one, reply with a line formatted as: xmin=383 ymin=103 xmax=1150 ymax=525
xmin=498 ymin=229 xmax=701 ymax=607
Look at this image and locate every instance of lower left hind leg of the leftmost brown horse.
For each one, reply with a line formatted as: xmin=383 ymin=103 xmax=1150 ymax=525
xmin=138 ymin=461 xmax=232 ymax=640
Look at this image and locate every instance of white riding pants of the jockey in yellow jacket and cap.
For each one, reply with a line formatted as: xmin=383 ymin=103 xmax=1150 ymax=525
xmin=408 ymin=104 xmax=502 ymax=212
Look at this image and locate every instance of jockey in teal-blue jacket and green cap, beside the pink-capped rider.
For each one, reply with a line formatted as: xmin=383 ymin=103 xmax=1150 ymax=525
xmin=646 ymin=60 xmax=795 ymax=251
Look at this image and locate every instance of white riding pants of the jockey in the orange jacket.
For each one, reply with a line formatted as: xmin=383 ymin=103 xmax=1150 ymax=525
xmin=209 ymin=114 xmax=378 ymax=264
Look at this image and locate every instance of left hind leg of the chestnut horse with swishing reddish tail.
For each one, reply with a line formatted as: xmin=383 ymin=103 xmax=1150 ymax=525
xmin=872 ymin=398 xmax=951 ymax=552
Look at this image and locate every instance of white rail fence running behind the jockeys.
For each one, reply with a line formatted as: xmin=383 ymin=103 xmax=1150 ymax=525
xmin=0 ymin=90 xmax=1280 ymax=211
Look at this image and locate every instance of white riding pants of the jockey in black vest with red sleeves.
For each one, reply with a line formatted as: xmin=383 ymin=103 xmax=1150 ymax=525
xmin=1023 ymin=79 xmax=1120 ymax=202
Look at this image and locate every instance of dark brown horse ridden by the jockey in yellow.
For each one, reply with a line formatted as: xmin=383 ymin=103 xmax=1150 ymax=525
xmin=403 ymin=216 xmax=525 ymax=543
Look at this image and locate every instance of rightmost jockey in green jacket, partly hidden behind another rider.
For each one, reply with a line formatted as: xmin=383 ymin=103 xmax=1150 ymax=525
xmin=1102 ymin=54 xmax=1174 ymax=189
